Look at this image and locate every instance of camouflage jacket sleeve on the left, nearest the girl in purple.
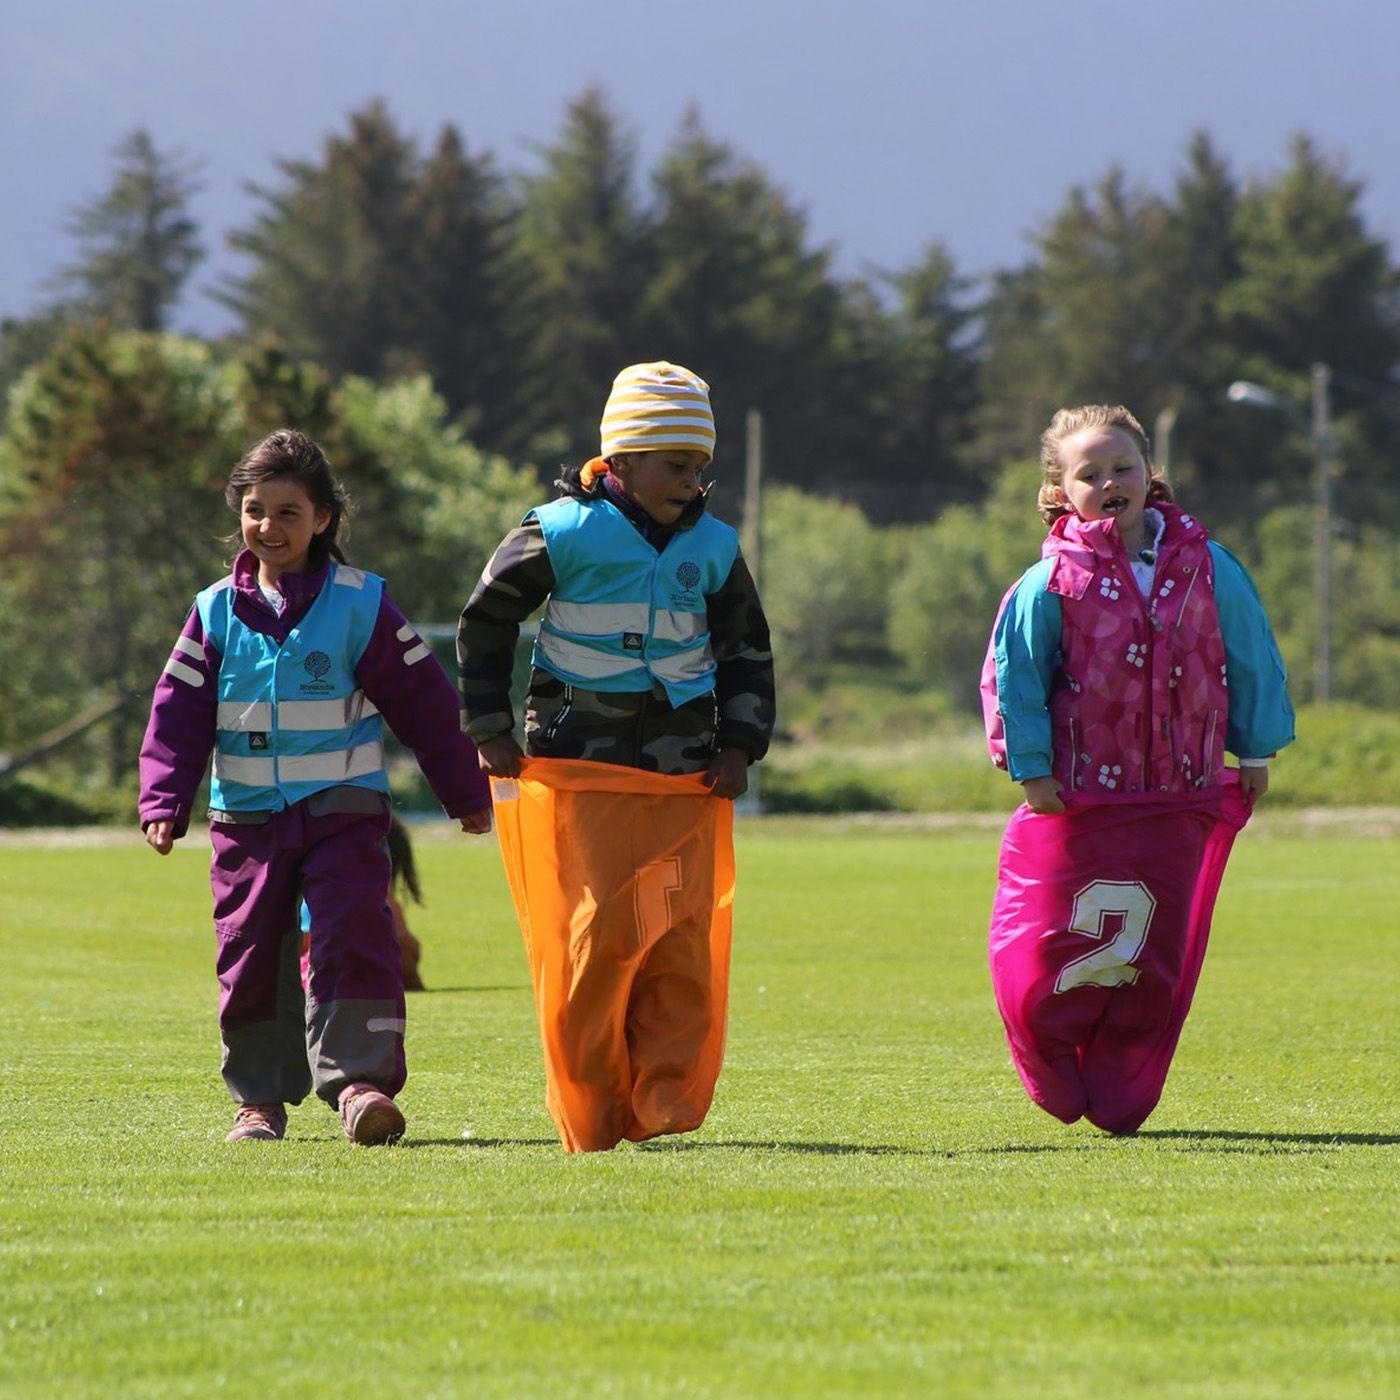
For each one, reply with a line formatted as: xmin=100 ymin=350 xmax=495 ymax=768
xmin=456 ymin=518 xmax=554 ymax=742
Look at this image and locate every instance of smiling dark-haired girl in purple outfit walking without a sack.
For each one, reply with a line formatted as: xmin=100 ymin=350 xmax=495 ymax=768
xmin=140 ymin=430 xmax=491 ymax=1147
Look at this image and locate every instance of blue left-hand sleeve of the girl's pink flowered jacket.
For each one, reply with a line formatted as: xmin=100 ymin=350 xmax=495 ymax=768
xmin=993 ymin=559 xmax=1063 ymax=783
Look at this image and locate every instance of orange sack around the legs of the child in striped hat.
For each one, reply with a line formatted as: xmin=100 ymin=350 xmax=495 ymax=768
xmin=491 ymin=759 xmax=734 ymax=1152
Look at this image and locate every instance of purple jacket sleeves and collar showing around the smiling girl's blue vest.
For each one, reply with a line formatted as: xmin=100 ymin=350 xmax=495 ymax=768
xmin=139 ymin=550 xmax=491 ymax=836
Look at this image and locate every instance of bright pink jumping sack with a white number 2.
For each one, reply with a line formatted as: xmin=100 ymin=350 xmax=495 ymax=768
xmin=988 ymin=773 xmax=1249 ymax=1133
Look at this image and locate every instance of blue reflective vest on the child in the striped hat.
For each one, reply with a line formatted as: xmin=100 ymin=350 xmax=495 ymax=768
xmin=526 ymin=497 xmax=739 ymax=706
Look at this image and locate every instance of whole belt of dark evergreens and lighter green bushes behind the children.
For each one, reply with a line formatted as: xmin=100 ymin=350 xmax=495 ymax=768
xmin=0 ymin=90 xmax=1400 ymax=800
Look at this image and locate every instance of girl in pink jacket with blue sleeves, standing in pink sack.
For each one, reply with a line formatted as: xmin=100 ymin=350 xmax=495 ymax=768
xmin=983 ymin=405 xmax=1294 ymax=1133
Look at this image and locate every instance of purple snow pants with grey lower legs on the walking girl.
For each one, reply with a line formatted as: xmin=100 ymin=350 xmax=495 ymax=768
xmin=210 ymin=788 xmax=407 ymax=1106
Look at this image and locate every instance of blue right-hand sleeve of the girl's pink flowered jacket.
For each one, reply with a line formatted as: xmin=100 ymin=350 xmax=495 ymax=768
xmin=1210 ymin=540 xmax=1294 ymax=759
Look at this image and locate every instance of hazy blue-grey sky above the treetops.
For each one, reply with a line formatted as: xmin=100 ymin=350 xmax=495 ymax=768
xmin=0 ymin=0 xmax=1400 ymax=335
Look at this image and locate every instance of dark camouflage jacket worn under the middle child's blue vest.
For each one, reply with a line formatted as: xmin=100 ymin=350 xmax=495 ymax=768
xmin=456 ymin=469 xmax=773 ymax=773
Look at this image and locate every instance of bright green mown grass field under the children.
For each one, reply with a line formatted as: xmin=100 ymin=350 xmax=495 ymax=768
xmin=0 ymin=818 xmax=1400 ymax=1397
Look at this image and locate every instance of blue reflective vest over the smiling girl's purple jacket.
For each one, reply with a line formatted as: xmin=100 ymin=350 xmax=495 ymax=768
xmin=195 ymin=563 xmax=389 ymax=812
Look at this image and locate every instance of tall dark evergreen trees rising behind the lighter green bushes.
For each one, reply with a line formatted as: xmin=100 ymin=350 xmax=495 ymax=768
xmin=8 ymin=91 xmax=1400 ymax=525
